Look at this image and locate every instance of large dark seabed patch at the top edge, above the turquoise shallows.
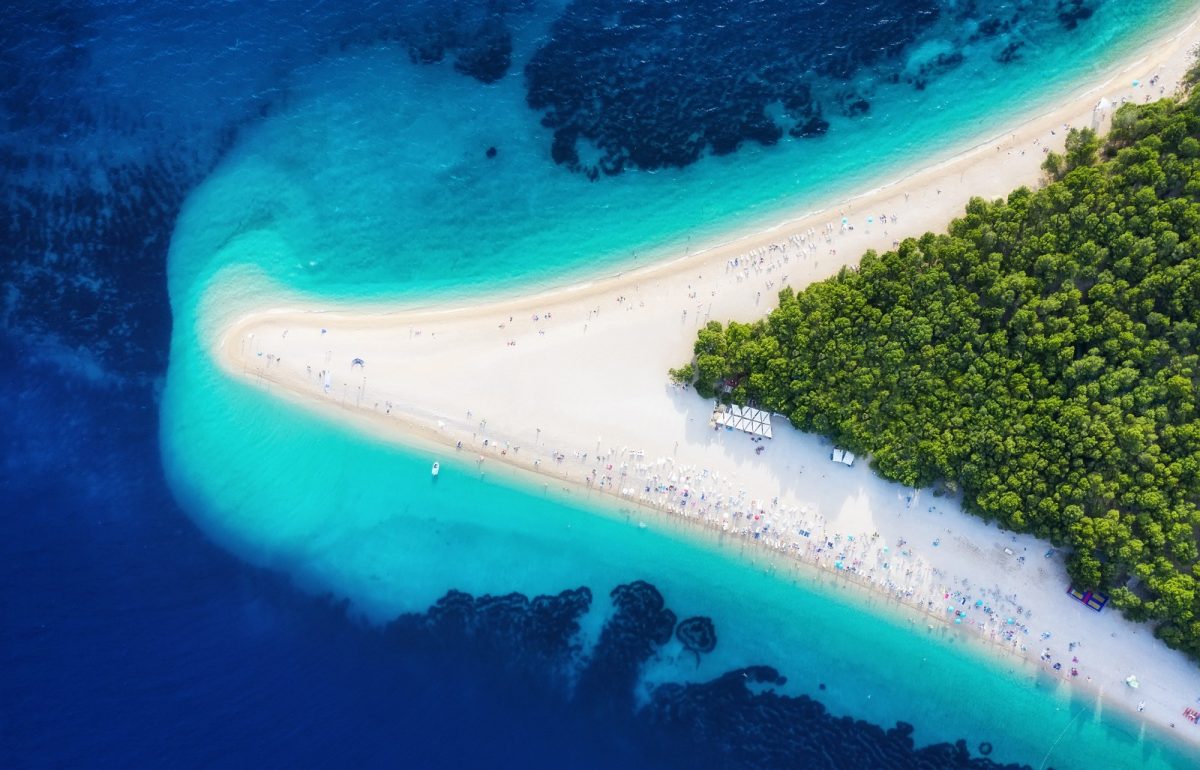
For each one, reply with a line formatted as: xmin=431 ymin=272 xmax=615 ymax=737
xmin=524 ymin=0 xmax=1092 ymax=179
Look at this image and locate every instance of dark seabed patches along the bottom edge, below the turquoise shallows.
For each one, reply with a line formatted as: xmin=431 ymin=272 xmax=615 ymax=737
xmin=384 ymin=580 xmax=1027 ymax=770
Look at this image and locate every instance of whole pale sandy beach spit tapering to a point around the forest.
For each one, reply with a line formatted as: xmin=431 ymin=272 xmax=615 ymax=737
xmin=214 ymin=20 xmax=1200 ymax=746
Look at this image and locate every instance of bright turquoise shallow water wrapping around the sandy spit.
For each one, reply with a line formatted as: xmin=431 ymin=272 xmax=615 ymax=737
xmin=162 ymin=2 xmax=1189 ymax=768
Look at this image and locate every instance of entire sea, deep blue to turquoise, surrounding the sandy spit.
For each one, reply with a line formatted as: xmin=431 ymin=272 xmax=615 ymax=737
xmin=7 ymin=0 xmax=1189 ymax=769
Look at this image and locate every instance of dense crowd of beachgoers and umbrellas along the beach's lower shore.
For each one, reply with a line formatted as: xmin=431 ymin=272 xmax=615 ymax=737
xmin=453 ymin=417 xmax=1090 ymax=679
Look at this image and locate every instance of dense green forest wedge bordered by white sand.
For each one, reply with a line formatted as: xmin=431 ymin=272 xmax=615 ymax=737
xmin=671 ymin=76 xmax=1200 ymax=660
